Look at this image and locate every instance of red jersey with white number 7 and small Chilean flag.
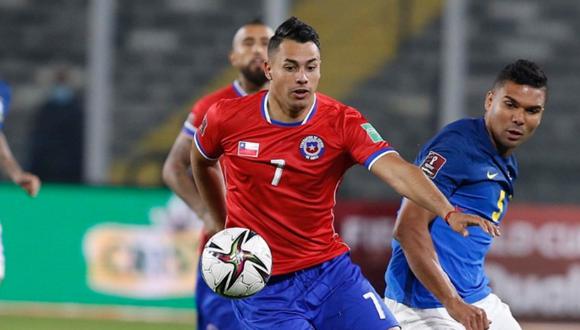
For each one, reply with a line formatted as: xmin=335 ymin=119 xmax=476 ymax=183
xmin=194 ymin=91 xmax=395 ymax=275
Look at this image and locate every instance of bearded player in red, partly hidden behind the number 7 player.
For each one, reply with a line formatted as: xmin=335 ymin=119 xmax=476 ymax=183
xmin=163 ymin=20 xmax=274 ymax=330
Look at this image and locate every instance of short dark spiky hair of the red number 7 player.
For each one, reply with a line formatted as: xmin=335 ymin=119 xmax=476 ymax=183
xmin=268 ymin=16 xmax=320 ymax=54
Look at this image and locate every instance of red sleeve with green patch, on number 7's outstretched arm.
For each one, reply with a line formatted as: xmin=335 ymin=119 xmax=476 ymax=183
xmin=342 ymin=108 xmax=396 ymax=170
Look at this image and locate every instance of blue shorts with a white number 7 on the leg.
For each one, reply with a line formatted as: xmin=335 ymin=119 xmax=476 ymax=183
xmin=232 ymin=253 xmax=398 ymax=330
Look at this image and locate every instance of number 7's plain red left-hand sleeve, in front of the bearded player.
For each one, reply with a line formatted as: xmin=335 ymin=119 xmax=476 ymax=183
xmin=195 ymin=102 xmax=223 ymax=160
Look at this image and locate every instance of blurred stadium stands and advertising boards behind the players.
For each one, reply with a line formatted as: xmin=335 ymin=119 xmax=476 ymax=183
xmin=0 ymin=0 xmax=580 ymax=329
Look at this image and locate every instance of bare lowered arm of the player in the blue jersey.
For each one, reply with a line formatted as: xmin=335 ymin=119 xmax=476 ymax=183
xmin=394 ymin=199 xmax=489 ymax=329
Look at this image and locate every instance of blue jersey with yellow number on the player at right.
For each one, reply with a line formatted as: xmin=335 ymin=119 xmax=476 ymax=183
xmin=385 ymin=118 xmax=517 ymax=308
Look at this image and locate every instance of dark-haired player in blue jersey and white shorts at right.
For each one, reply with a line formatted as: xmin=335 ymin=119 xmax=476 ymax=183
xmin=385 ymin=60 xmax=547 ymax=329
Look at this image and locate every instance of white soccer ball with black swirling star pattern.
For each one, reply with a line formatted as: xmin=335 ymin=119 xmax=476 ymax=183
xmin=201 ymin=227 xmax=272 ymax=298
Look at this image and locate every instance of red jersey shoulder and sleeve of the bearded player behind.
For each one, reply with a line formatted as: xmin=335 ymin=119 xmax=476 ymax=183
xmin=182 ymin=80 xmax=248 ymax=139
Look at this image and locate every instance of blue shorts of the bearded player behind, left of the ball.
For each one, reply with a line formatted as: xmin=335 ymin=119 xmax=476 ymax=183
xmin=195 ymin=263 xmax=240 ymax=330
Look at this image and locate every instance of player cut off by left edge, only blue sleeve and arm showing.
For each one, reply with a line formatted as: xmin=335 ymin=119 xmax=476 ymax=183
xmin=0 ymin=80 xmax=40 ymax=282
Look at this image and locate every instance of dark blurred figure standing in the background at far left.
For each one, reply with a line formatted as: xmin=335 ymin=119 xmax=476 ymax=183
xmin=30 ymin=66 xmax=84 ymax=183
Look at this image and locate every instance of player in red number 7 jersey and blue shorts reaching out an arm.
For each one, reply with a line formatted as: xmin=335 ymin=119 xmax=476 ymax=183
xmin=191 ymin=17 xmax=496 ymax=330
